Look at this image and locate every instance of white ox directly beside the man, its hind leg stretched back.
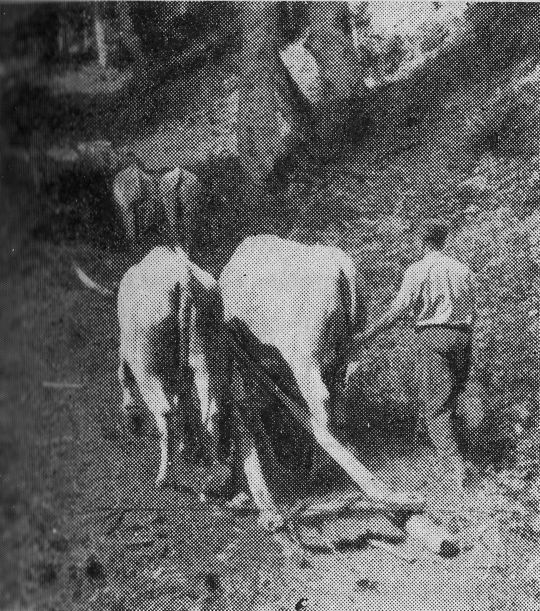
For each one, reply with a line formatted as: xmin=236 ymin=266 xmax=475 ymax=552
xmin=219 ymin=235 xmax=420 ymax=521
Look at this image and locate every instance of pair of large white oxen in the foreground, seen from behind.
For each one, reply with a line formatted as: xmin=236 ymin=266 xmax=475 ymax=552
xmin=82 ymin=235 xmax=421 ymax=529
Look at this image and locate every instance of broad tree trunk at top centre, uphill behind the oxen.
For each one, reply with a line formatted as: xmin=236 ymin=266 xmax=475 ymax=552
xmin=237 ymin=2 xmax=306 ymax=185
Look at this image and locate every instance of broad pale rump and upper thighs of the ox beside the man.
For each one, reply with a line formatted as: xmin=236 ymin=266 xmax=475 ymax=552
xmin=219 ymin=235 xmax=363 ymax=408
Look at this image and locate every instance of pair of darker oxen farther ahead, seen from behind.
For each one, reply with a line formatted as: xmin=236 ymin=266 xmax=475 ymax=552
xmin=112 ymin=161 xmax=202 ymax=252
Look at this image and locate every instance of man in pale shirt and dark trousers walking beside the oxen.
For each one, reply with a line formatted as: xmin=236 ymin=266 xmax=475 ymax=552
xmin=355 ymin=221 xmax=474 ymax=498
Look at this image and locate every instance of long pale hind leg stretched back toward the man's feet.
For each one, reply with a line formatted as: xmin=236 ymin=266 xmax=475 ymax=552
xmin=293 ymin=363 xmax=421 ymax=507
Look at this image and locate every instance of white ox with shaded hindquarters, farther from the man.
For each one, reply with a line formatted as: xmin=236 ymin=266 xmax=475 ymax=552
xmin=118 ymin=247 xmax=226 ymax=486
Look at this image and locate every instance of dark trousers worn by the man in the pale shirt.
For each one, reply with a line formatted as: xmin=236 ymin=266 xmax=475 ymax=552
xmin=416 ymin=326 xmax=472 ymax=458
